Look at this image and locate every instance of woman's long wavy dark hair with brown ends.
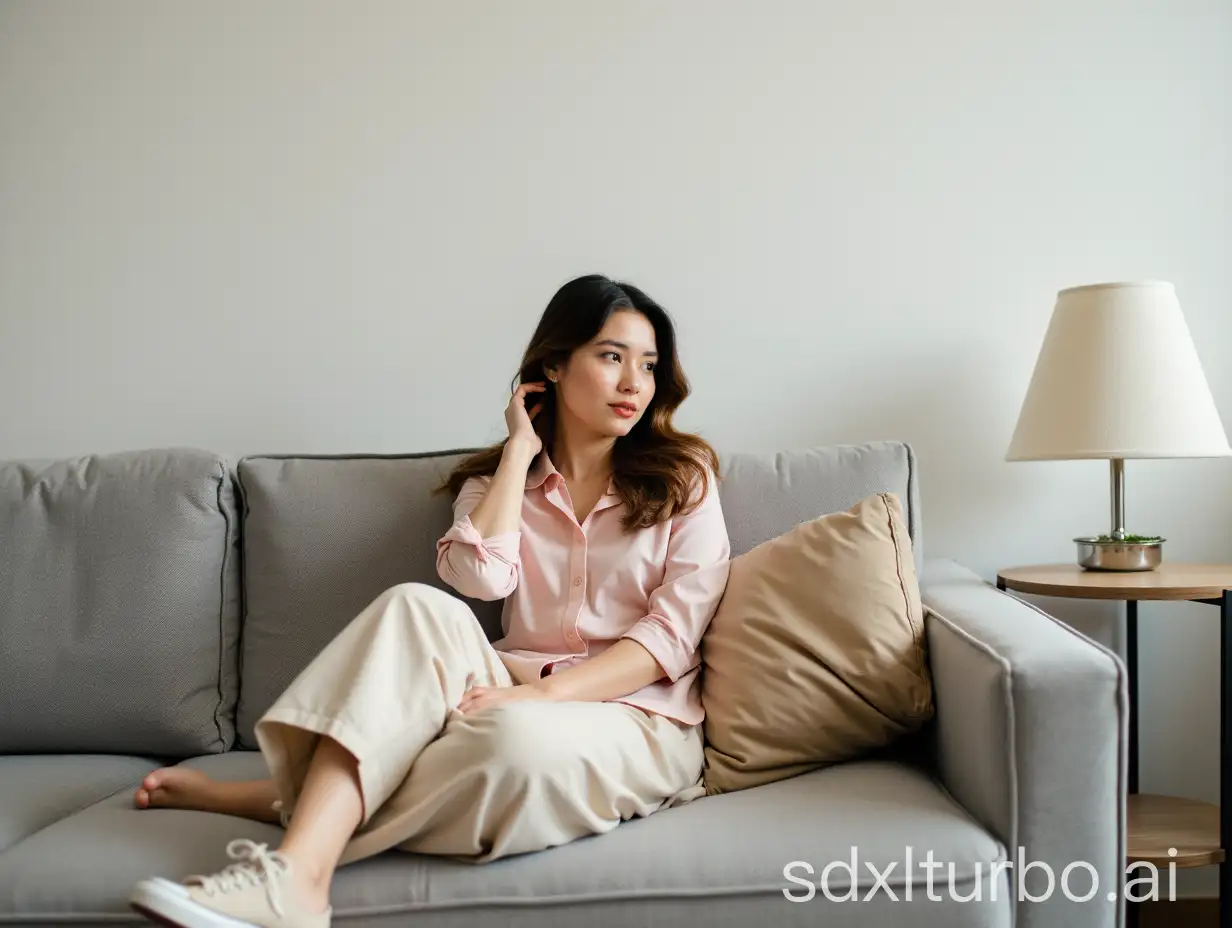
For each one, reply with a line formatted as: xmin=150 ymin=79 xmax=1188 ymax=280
xmin=439 ymin=274 xmax=719 ymax=531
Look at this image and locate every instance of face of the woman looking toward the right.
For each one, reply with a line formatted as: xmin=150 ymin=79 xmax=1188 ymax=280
xmin=553 ymin=309 xmax=659 ymax=438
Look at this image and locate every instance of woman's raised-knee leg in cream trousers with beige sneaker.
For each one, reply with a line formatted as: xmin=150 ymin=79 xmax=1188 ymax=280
xmin=132 ymin=583 xmax=513 ymax=928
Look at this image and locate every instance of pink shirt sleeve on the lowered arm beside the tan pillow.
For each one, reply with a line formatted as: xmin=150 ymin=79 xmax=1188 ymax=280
xmin=621 ymin=474 xmax=732 ymax=683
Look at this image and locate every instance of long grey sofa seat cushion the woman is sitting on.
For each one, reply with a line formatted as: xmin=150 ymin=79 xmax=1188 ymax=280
xmin=0 ymin=754 xmax=1011 ymax=928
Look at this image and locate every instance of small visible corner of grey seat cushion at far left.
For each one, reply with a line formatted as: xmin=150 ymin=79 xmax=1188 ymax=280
xmin=0 ymin=754 xmax=158 ymax=853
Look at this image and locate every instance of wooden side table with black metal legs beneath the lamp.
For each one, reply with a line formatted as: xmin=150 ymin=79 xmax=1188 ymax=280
xmin=997 ymin=563 xmax=1232 ymax=928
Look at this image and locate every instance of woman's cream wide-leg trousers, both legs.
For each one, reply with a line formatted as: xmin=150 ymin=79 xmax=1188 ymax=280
xmin=256 ymin=583 xmax=702 ymax=864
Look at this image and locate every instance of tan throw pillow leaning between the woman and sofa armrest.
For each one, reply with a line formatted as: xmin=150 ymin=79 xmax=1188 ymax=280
xmin=701 ymin=493 xmax=933 ymax=795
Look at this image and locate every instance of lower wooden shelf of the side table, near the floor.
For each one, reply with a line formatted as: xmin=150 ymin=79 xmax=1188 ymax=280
xmin=1127 ymin=792 xmax=1223 ymax=868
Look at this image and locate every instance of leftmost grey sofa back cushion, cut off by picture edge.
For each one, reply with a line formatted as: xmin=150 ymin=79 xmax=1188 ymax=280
xmin=0 ymin=449 xmax=239 ymax=757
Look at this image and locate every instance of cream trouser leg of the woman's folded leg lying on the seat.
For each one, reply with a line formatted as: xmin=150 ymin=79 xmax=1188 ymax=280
xmin=341 ymin=701 xmax=703 ymax=864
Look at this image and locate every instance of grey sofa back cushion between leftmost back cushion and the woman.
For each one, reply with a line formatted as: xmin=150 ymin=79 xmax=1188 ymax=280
xmin=237 ymin=451 xmax=501 ymax=748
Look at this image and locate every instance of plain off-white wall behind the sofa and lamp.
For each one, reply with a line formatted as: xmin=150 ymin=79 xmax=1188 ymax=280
xmin=0 ymin=0 xmax=1232 ymax=886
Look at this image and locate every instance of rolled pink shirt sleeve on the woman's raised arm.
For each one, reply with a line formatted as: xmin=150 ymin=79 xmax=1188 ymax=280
xmin=436 ymin=477 xmax=521 ymax=600
